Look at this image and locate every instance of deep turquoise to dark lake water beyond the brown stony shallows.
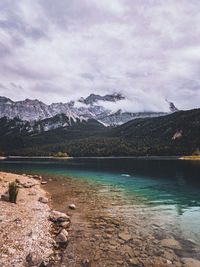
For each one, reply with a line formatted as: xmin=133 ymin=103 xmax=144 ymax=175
xmin=0 ymin=158 xmax=200 ymax=244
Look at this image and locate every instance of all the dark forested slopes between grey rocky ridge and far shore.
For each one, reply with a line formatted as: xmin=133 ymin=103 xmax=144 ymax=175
xmin=0 ymin=109 xmax=200 ymax=156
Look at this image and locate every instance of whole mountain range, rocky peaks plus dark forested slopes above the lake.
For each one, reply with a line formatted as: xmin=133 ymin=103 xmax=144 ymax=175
xmin=0 ymin=94 xmax=200 ymax=156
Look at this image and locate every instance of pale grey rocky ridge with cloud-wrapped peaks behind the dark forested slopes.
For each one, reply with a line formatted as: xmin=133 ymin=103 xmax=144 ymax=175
xmin=0 ymin=93 xmax=178 ymax=130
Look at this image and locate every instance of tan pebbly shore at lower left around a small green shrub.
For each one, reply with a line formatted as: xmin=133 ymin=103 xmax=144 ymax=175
xmin=0 ymin=172 xmax=55 ymax=267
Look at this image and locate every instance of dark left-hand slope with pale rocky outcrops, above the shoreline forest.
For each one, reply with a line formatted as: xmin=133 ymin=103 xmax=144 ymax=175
xmin=0 ymin=114 xmax=107 ymax=151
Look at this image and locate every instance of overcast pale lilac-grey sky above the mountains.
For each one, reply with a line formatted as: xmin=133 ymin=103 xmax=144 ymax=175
xmin=0 ymin=0 xmax=200 ymax=111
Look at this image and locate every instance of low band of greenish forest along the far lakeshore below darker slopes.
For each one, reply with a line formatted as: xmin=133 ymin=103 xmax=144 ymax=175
xmin=8 ymin=138 xmax=200 ymax=157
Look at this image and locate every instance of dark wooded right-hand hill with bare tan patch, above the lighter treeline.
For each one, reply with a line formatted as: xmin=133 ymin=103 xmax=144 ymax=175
xmin=110 ymin=109 xmax=200 ymax=140
